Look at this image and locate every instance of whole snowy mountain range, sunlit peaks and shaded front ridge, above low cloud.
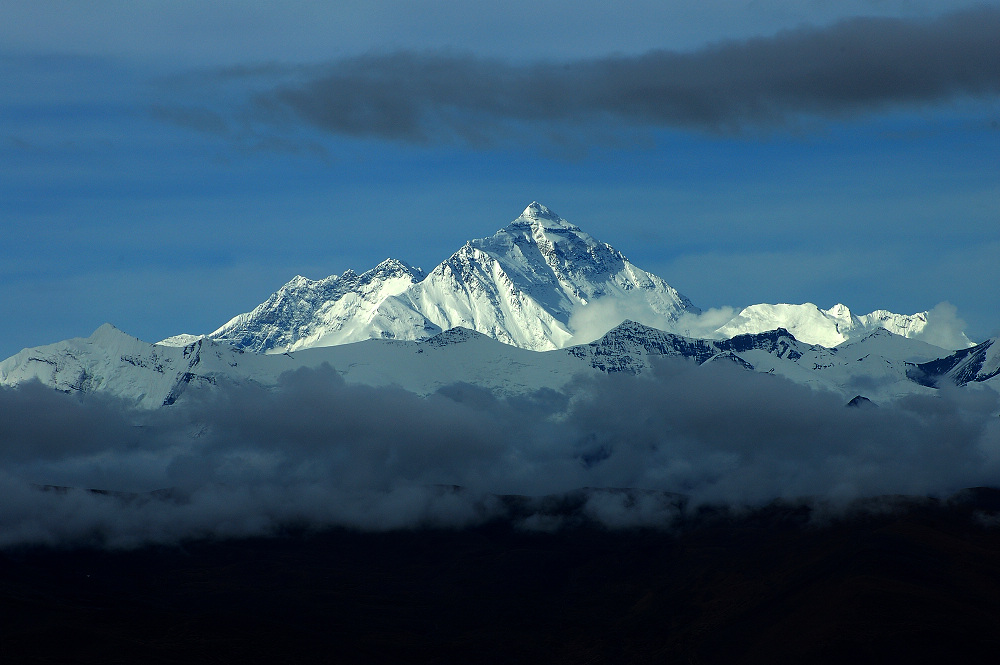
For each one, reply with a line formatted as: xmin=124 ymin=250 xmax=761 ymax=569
xmin=0 ymin=202 xmax=1000 ymax=408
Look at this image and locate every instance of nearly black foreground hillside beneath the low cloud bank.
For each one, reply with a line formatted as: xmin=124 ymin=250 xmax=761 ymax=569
xmin=0 ymin=490 xmax=1000 ymax=663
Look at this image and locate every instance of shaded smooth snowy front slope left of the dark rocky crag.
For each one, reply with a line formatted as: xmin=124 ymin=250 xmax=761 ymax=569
xmin=0 ymin=324 xmax=598 ymax=408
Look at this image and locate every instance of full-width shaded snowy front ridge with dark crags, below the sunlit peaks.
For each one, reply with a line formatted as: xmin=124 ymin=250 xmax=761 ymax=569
xmin=0 ymin=321 xmax=960 ymax=408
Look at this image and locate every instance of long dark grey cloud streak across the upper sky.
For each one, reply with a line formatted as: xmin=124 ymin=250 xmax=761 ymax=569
xmin=225 ymin=8 xmax=1000 ymax=144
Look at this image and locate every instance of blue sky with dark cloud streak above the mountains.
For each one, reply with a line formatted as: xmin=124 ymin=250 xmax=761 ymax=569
xmin=0 ymin=0 xmax=1000 ymax=358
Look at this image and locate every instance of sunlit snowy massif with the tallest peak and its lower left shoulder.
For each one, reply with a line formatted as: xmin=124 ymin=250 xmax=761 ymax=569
xmin=161 ymin=202 xmax=700 ymax=353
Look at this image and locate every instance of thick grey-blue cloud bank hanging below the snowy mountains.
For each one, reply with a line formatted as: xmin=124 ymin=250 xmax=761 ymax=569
xmin=0 ymin=361 xmax=1000 ymax=547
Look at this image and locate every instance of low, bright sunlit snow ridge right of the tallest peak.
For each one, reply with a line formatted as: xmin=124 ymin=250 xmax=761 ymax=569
xmin=716 ymin=303 xmax=972 ymax=348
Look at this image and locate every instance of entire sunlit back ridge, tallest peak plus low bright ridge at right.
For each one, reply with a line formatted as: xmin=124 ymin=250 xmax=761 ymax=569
xmin=159 ymin=201 xmax=960 ymax=353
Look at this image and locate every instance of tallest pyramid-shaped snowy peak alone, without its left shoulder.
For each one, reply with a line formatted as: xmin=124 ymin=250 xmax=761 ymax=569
xmin=386 ymin=202 xmax=698 ymax=351
